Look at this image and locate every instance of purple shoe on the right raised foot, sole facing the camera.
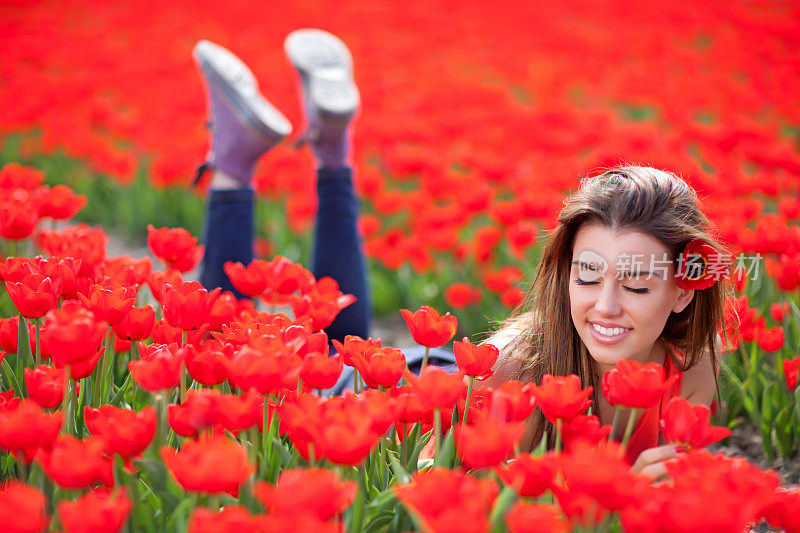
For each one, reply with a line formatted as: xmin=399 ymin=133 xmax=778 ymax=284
xmin=284 ymin=29 xmax=360 ymax=168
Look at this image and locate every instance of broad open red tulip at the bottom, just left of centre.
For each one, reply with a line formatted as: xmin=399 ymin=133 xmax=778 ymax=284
xmin=255 ymin=468 xmax=358 ymax=521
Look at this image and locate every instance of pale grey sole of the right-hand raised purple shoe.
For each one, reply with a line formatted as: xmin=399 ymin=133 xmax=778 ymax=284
xmin=284 ymin=29 xmax=361 ymax=121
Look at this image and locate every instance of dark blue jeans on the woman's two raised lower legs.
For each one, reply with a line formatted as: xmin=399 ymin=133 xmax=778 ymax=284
xmin=200 ymin=167 xmax=371 ymax=341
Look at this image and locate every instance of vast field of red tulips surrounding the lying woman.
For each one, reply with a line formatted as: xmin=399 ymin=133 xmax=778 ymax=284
xmin=0 ymin=0 xmax=800 ymax=533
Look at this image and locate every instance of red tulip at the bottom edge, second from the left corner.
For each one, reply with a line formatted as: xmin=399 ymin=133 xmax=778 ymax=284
xmin=56 ymin=489 xmax=133 ymax=533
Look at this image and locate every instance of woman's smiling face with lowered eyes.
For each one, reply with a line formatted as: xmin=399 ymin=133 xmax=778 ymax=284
xmin=569 ymin=223 xmax=694 ymax=372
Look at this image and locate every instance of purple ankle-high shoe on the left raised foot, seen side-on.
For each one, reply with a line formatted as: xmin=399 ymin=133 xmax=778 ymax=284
xmin=192 ymin=40 xmax=292 ymax=187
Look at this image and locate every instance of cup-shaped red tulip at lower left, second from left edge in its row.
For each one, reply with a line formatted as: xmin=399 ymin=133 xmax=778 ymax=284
xmin=83 ymin=405 xmax=156 ymax=460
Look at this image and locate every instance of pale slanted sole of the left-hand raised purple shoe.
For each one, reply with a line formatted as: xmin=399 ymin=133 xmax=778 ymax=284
xmin=192 ymin=40 xmax=292 ymax=144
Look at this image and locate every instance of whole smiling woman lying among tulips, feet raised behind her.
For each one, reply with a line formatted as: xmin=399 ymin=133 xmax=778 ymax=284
xmin=194 ymin=30 xmax=725 ymax=470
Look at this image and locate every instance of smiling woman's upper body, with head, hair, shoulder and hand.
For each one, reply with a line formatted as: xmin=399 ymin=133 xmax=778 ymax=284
xmin=484 ymin=167 xmax=725 ymax=477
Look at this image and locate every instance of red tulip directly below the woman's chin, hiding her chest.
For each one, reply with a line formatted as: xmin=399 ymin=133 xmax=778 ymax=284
xmin=602 ymin=359 xmax=678 ymax=409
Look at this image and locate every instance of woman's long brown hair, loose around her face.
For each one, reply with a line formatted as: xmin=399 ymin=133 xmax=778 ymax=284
xmin=504 ymin=166 xmax=726 ymax=448
